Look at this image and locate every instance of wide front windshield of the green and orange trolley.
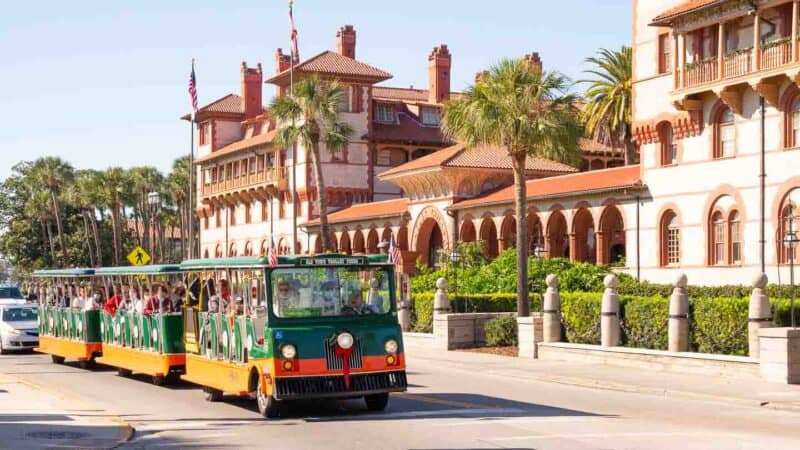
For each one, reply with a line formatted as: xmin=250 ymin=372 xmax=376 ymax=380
xmin=270 ymin=267 xmax=392 ymax=317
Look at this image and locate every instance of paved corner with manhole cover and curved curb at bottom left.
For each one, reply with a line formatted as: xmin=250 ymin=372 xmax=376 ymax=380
xmin=0 ymin=374 xmax=133 ymax=449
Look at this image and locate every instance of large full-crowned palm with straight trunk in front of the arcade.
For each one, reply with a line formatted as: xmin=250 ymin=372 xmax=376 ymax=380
xmin=442 ymin=59 xmax=583 ymax=317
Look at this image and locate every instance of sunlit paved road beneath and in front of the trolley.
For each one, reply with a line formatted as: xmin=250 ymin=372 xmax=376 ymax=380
xmin=0 ymin=348 xmax=800 ymax=450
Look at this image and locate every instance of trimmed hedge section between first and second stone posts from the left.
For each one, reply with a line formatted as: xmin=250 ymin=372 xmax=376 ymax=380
xmin=561 ymin=292 xmax=602 ymax=344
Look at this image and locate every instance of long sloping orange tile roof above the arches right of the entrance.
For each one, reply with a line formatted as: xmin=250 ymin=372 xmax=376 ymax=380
xmin=451 ymin=165 xmax=642 ymax=209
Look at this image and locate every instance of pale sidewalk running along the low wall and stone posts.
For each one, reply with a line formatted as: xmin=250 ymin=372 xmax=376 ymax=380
xmin=403 ymin=333 xmax=800 ymax=413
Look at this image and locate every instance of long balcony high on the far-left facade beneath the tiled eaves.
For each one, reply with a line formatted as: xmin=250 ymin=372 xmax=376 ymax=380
xmin=201 ymin=167 xmax=288 ymax=204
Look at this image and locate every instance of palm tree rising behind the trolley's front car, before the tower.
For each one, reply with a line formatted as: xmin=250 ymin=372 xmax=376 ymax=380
xmin=270 ymin=76 xmax=353 ymax=250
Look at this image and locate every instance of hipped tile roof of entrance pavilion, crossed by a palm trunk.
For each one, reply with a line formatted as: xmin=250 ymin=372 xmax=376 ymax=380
xmin=379 ymin=144 xmax=578 ymax=179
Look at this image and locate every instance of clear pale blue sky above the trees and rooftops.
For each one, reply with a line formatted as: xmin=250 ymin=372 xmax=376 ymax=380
xmin=0 ymin=0 xmax=632 ymax=180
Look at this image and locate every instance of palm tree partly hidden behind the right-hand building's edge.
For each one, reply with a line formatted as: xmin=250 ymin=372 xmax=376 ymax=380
xmin=580 ymin=46 xmax=637 ymax=165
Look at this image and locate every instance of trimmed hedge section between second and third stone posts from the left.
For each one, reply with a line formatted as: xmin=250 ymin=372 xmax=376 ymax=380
xmin=620 ymin=296 xmax=669 ymax=350
